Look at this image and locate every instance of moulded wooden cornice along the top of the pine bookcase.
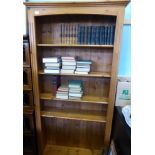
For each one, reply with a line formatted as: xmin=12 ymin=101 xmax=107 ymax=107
xmin=24 ymin=0 xmax=130 ymax=7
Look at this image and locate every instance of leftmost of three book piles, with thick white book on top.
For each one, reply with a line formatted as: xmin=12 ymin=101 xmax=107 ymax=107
xmin=43 ymin=57 xmax=61 ymax=74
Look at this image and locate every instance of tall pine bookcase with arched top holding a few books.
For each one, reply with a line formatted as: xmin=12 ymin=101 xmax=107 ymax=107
xmin=25 ymin=0 xmax=128 ymax=155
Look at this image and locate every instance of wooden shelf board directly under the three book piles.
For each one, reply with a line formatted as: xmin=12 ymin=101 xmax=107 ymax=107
xmin=38 ymin=70 xmax=111 ymax=78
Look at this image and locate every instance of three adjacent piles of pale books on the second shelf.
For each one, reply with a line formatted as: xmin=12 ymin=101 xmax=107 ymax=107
xmin=43 ymin=57 xmax=92 ymax=74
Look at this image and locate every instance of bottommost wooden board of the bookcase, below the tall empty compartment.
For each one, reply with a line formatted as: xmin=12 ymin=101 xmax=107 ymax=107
xmin=44 ymin=145 xmax=102 ymax=155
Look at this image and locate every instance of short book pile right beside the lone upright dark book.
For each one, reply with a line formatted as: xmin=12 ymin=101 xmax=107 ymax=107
xmin=56 ymin=85 xmax=69 ymax=100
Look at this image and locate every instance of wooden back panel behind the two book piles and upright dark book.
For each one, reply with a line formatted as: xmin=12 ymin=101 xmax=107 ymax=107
xmin=39 ymin=75 xmax=110 ymax=97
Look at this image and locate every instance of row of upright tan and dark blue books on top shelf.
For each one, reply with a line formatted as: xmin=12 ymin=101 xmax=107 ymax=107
xmin=60 ymin=24 xmax=115 ymax=45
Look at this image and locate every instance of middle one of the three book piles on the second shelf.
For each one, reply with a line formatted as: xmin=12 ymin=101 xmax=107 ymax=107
xmin=61 ymin=57 xmax=76 ymax=74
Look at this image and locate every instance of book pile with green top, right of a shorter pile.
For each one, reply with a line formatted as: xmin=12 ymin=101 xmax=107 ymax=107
xmin=69 ymin=80 xmax=83 ymax=100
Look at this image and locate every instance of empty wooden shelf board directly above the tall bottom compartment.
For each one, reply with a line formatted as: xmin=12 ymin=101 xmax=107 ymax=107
xmin=41 ymin=109 xmax=106 ymax=123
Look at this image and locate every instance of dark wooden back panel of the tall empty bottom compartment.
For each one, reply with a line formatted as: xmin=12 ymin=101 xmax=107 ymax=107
xmin=42 ymin=118 xmax=105 ymax=149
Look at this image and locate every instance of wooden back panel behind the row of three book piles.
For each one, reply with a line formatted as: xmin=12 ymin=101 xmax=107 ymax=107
xmin=38 ymin=48 xmax=113 ymax=72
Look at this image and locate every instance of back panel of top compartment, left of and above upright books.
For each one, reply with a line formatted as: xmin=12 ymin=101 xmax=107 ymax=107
xmin=36 ymin=14 xmax=116 ymax=44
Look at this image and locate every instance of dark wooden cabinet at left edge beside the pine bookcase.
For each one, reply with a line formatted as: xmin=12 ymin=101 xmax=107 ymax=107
xmin=23 ymin=36 xmax=37 ymax=155
